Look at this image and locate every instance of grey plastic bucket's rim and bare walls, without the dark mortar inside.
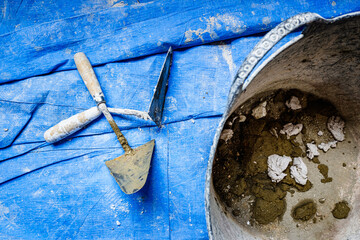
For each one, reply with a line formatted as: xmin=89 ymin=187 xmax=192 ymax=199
xmin=205 ymin=12 xmax=360 ymax=239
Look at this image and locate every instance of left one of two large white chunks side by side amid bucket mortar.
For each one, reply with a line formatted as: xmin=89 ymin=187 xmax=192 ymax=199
xmin=267 ymin=154 xmax=292 ymax=182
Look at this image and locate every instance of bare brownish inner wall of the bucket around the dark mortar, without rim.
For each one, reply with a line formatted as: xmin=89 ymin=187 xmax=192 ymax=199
xmin=208 ymin=16 xmax=360 ymax=239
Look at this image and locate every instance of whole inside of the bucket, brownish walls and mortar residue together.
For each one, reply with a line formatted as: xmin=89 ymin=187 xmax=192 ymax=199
xmin=206 ymin=14 xmax=360 ymax=239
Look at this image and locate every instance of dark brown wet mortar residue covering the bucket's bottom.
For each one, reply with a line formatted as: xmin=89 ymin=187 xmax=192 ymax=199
xmin=212 ymin=90 xmax=350 ymax=229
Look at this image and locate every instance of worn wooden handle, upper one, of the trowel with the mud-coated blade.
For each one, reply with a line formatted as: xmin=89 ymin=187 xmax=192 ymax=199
xmin=74 ymin=52 xmax=105 ymax=104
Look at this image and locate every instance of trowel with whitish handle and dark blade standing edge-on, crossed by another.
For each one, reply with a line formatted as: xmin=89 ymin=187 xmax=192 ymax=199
xmin=44 ymin=47 xmax=172 ymax=143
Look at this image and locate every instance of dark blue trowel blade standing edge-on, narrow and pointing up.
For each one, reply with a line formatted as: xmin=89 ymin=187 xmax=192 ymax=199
xmin=148 ymin=47 xmax=172 ymax=127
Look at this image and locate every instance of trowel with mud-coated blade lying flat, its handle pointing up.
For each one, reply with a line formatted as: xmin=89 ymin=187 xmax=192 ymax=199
xmin=74 ymin=52 xmax=172 ymax=194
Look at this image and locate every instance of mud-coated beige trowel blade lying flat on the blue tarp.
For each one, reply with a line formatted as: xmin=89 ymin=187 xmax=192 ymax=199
xmin=105 ymin=140 xmax=155 ymax=194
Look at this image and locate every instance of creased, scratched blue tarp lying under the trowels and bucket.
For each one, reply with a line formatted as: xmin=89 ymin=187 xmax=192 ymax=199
xmin=0 ymin=0 xmax=360 ymax=239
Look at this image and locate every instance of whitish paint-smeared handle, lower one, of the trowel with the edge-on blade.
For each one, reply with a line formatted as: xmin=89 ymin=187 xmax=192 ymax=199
xmin=44 ymin=107 xmax=101 ymax=143
